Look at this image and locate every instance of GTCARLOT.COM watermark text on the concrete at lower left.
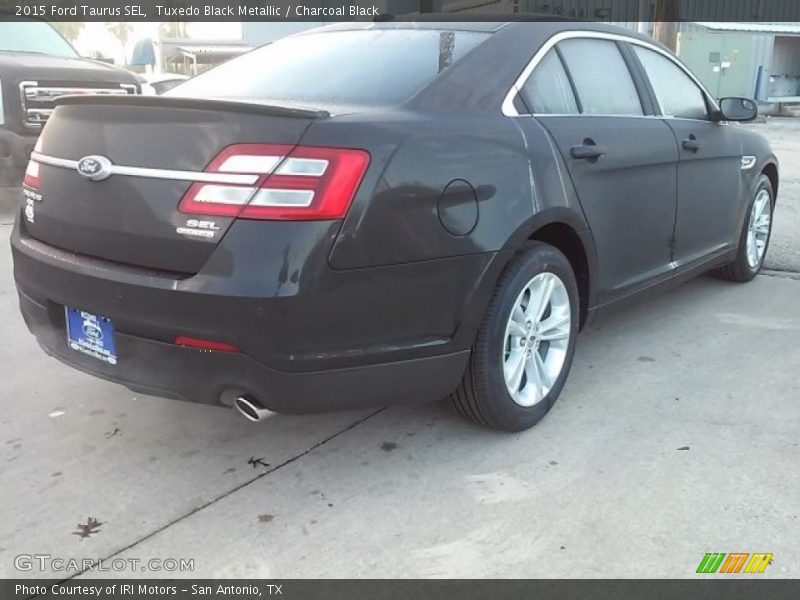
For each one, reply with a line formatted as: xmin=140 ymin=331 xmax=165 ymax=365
xmin=14 ymin=554 xmax=194 ymax=573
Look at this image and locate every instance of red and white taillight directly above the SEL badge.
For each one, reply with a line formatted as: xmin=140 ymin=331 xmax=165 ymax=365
xmin=178 ymin=144 xmax=370 ymax=221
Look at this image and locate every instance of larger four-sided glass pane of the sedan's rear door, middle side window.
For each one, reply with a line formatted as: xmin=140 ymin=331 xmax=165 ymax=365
xmin=558 ymin=39 xmax=644 ymax=115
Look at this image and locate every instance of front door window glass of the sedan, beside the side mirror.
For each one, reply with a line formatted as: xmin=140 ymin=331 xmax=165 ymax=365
xmin=633 ymin=46 xmax=708 ymax=120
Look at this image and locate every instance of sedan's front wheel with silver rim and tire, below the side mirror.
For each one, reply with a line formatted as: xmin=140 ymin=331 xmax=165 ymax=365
xmin=718 ymin=175 xmax=775 ymax=282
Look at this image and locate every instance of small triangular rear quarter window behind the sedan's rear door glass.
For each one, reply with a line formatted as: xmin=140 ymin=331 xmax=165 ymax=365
xmin=521 ymin=50 xmax=578 ymax=115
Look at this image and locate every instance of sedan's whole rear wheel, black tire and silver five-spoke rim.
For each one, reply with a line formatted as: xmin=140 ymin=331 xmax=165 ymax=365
xmin=451 ymin=242 xmax=578 ymax=431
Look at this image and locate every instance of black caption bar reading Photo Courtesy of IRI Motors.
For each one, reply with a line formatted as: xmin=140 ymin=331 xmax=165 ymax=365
xmin=0 ymin=576 xmax=800 ymax=600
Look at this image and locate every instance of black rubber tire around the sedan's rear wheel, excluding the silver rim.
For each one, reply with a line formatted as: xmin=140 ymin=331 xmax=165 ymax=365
xmin=450 ymin=242 xmax=579 ymax=432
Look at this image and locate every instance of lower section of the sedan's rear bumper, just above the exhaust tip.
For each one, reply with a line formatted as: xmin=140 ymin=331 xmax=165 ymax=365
xmin=20 ymin=292 xmax=469 ymax=413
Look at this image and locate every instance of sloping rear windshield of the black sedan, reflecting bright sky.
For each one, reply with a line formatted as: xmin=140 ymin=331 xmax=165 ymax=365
xmin=170 ymin=29 xmax=489 ymax=107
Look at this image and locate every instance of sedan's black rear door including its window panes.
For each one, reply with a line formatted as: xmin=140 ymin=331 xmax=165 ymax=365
xmin=522 ymin=37 xmax=678 ymax=303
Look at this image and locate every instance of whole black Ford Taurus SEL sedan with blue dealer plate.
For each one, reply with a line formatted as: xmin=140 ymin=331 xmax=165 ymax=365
xmin=12 ymin=22 xmax=778 ymax=431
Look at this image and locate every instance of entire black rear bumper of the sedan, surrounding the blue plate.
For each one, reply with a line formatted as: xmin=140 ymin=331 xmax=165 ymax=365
xmin=12 ymin=220 xmax=505 ymax=413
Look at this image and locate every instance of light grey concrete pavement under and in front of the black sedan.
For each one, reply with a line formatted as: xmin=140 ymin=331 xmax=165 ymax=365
xmin=0 ymin=227 xmax=800 ymax=577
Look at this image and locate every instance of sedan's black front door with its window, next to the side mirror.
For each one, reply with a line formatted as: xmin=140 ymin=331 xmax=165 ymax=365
xmin=633 ymin=46 xmax=743 ymax=267
